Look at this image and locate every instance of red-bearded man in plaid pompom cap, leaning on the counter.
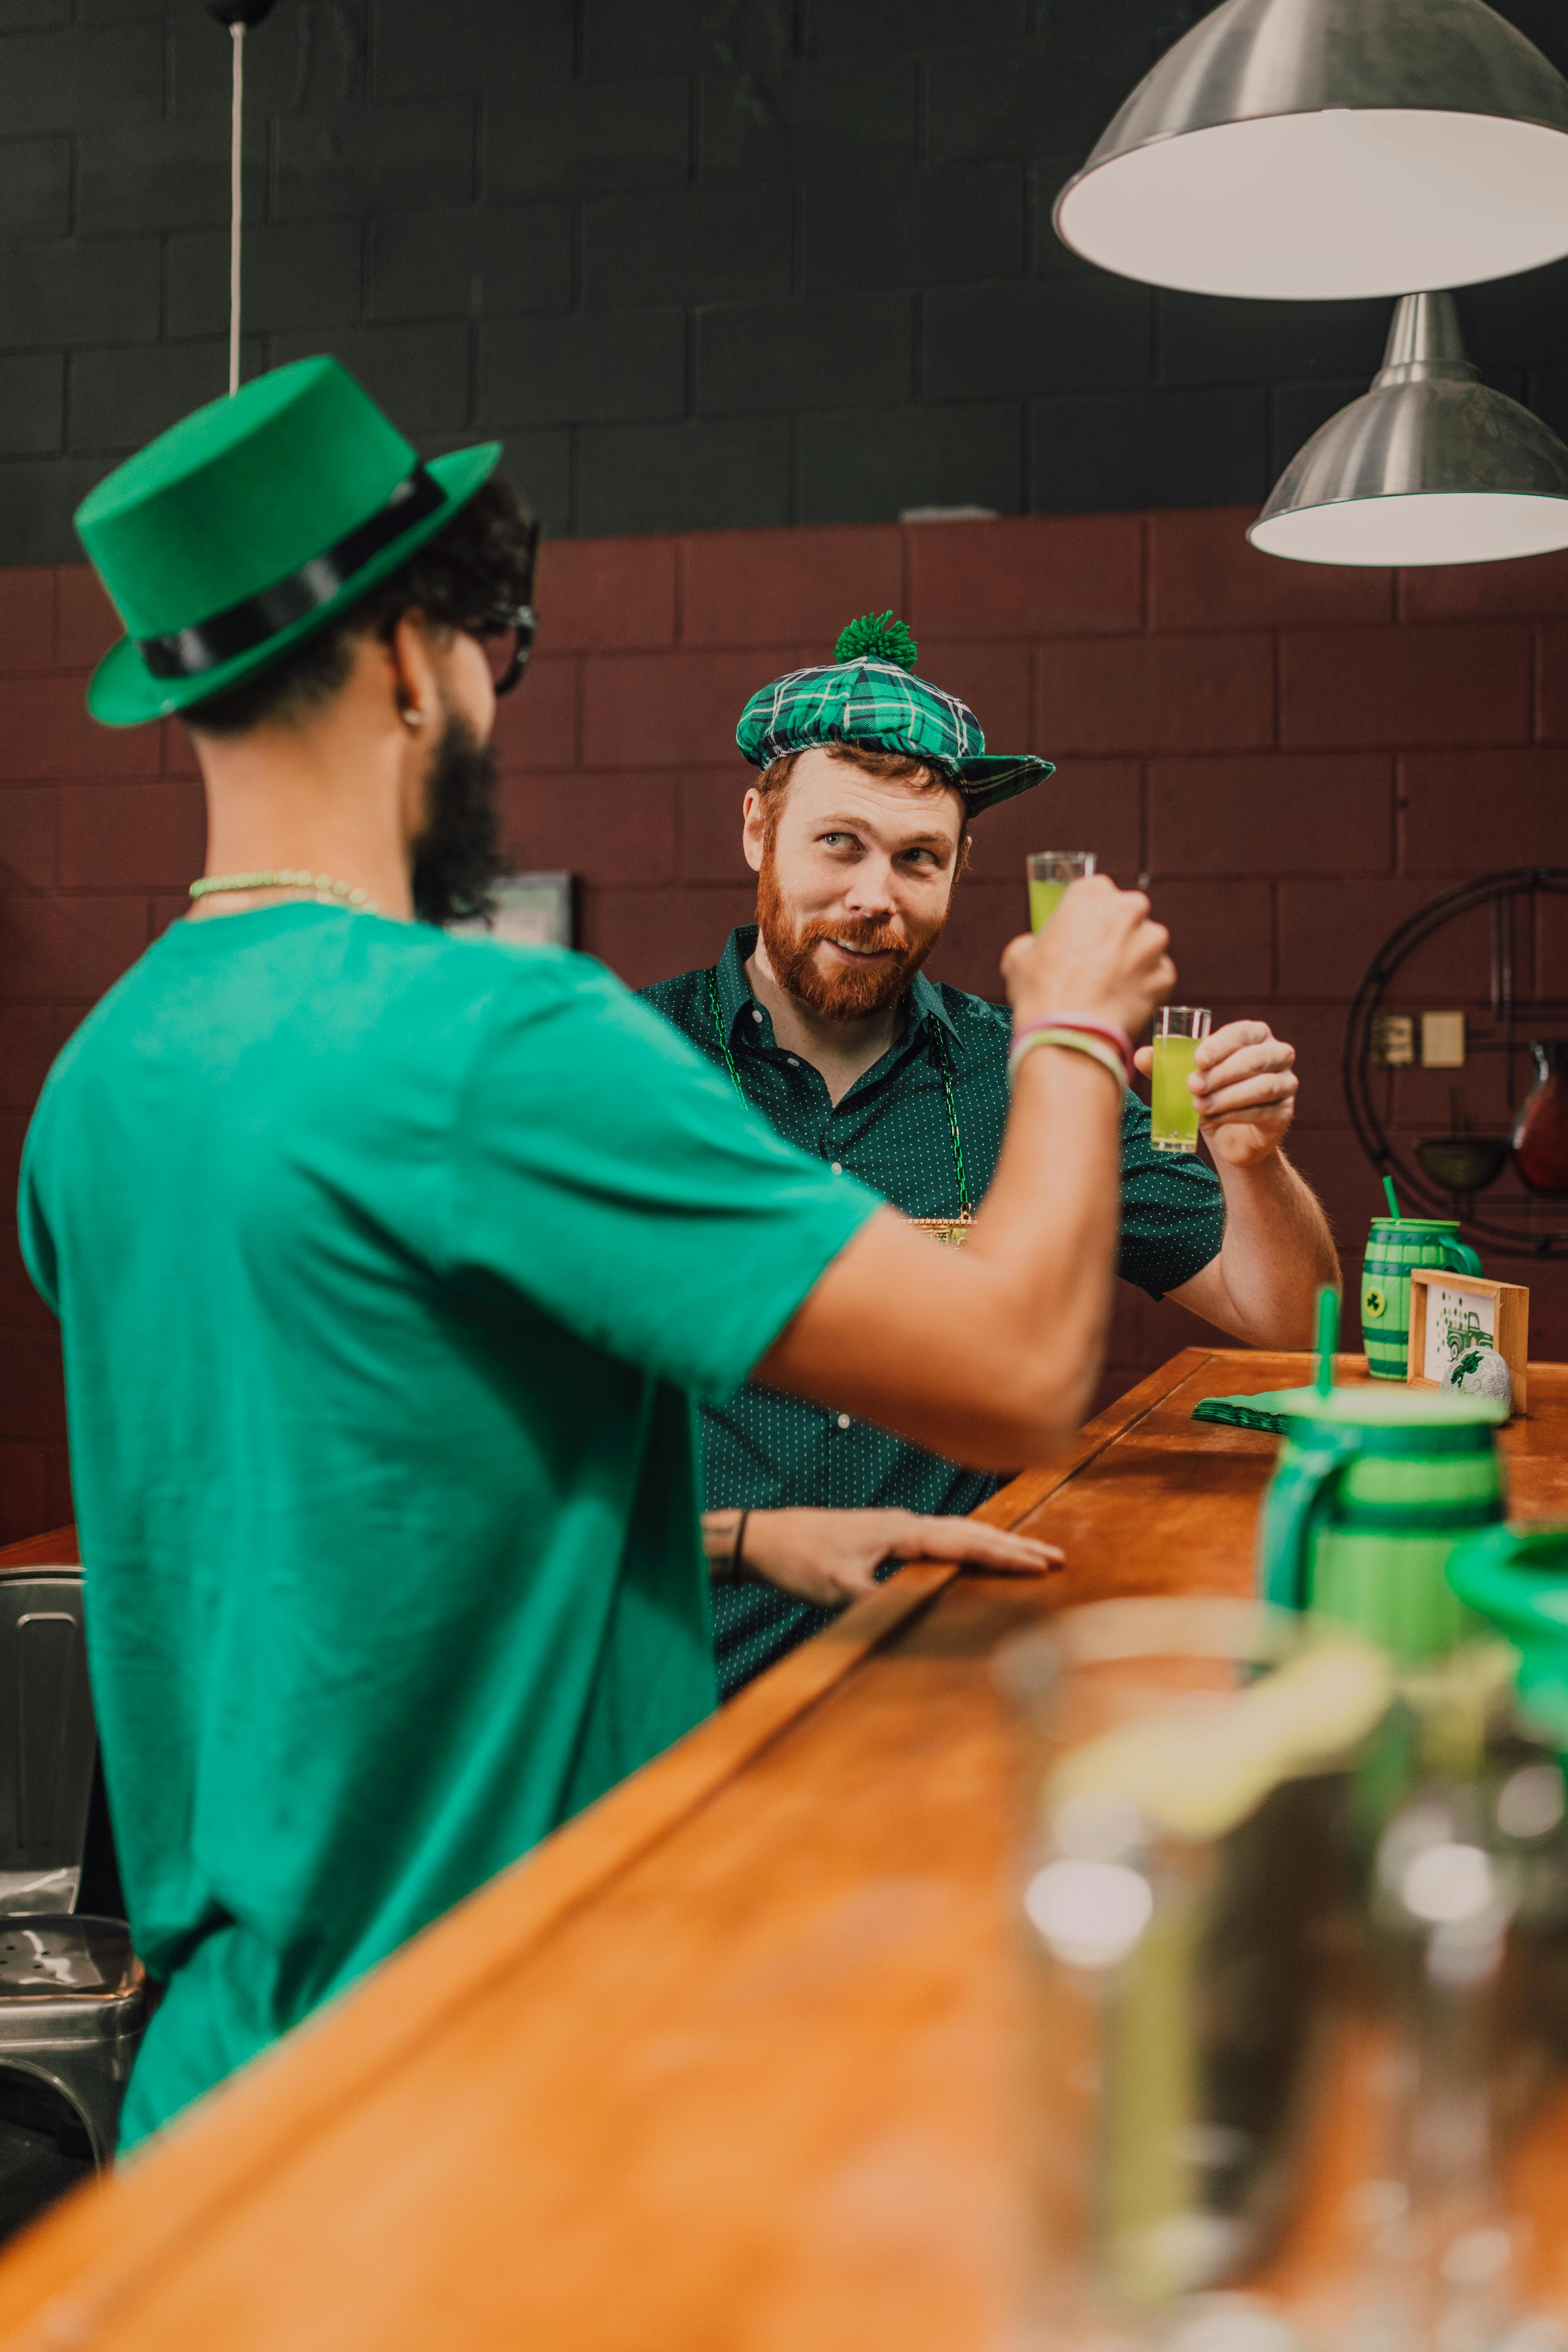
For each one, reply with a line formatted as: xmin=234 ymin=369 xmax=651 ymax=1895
xmin=644 ymin=614 xmax=1338 ymax=1693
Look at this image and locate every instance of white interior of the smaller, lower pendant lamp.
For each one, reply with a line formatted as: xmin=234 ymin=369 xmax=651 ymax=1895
xmin=1246 ymin=489 xmax=1568 ymax=567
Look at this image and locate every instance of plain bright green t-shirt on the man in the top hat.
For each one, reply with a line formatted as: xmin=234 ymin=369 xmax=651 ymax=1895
xmin=21 ymin=906 xmax=877 ymax=2145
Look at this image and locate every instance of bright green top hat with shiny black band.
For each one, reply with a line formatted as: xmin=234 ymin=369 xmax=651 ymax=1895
xmin=75 ymin=360 xmax=501 ymax=727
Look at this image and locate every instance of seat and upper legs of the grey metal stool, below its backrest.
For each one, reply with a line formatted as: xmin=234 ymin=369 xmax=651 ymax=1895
xmin=0 ymin=1912 xmax=148 ymax=2168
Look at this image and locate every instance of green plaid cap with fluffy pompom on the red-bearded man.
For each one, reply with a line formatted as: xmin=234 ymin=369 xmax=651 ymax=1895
xmin=736 ymin=611 xmax=1055 ymax=816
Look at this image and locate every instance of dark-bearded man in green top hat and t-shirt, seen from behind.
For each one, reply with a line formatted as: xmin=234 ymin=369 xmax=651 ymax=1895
xmin=19 ymin=360 xmax=1173 ymax=2145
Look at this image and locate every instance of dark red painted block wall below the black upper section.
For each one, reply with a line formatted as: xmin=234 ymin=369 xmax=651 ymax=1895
xmin=0 ymin=510 xmax=1568 ymax=1538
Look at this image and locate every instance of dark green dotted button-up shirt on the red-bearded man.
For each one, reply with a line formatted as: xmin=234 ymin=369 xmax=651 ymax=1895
xmin=642 ymin=924 xmax=1225 ymax=1698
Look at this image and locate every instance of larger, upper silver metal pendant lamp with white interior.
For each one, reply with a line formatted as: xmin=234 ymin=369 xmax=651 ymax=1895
xmin=1055 ymin=0 xmax=1568 ymax=301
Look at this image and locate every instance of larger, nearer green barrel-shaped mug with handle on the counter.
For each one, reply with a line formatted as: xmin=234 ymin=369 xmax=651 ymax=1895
xmin=1258 ymin=1388 xmax=1507 ymax=1660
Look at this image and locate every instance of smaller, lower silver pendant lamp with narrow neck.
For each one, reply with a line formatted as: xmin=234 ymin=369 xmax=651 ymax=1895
xmin=1246 ymin=294 xmax=1568 ymax=565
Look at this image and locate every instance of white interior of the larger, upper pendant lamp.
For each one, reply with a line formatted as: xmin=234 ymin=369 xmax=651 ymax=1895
xmin=1058 ymin=108 xmax=1568 ymax=301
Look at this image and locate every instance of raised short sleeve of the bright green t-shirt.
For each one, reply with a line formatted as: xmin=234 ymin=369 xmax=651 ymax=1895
xmin=444 ymin=955 xmax=882 ymax=1397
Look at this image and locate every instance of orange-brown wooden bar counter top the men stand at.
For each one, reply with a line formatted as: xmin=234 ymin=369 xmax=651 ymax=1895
xmin=0 ymin=1348 xmax=1568 ymax=2352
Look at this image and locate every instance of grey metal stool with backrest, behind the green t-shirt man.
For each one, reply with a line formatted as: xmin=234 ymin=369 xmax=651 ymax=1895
xmin=0 ymin=1566 xmax=148 ymax=2166
